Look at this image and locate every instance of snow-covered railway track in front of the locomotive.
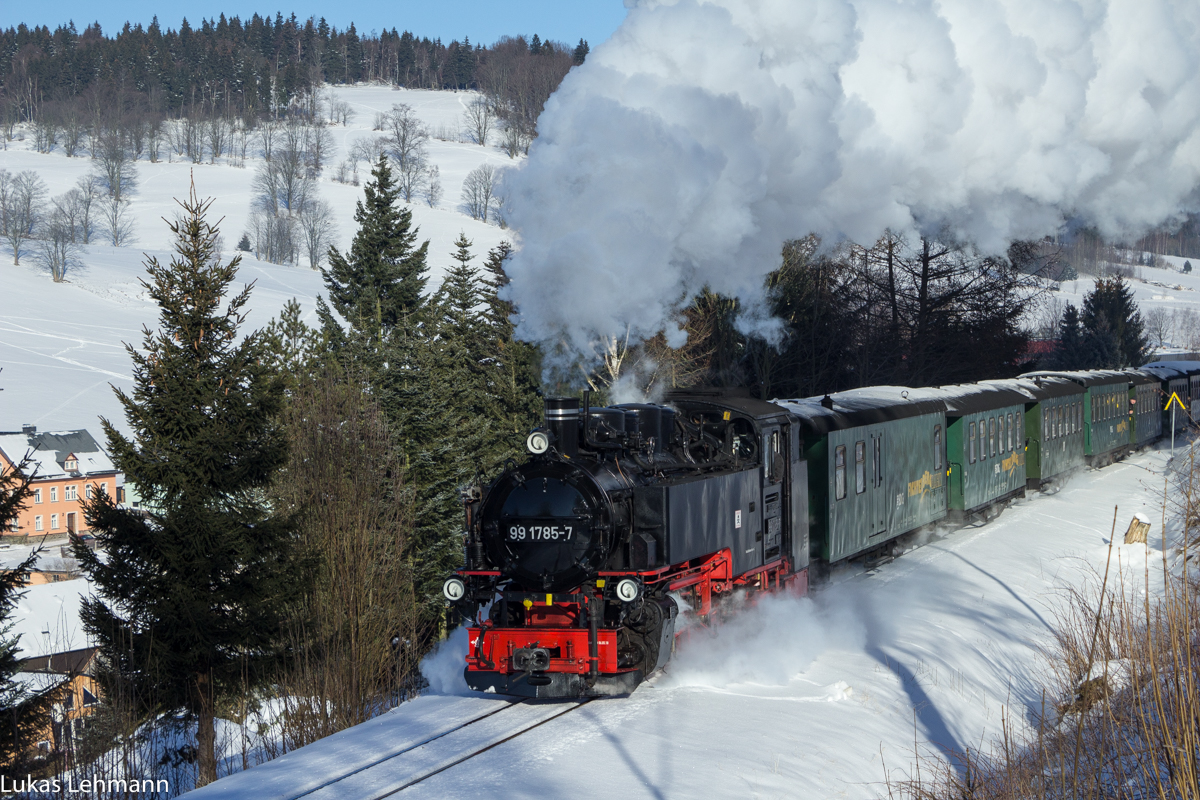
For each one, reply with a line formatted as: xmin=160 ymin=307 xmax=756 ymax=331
xmin=288 ymin=698 xmax=593 ymax=800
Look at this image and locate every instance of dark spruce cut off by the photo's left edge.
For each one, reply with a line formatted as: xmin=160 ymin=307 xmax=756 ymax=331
xmin=0 ymin=462 xmax=61 ymax=778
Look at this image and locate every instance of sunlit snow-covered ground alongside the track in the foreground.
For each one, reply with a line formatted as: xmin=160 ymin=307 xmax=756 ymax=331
xmin=184 ymin=450 xmax=1168 ymax=800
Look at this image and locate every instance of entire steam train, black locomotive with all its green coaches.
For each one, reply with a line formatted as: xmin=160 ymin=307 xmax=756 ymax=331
xmin=443 ymin=362 xmax=1200 ymax=697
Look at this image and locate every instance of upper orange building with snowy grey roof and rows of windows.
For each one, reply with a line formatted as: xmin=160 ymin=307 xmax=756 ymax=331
xmin=0 ymin=425 xmax=124 ymax=537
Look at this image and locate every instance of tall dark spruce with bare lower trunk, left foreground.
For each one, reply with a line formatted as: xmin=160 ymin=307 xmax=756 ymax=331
xmin=74 ymin=186 xmax=305 ymax=786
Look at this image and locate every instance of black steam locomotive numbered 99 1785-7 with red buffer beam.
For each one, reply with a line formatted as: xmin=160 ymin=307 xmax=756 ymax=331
xmin=445 ymin=393 xmax=809 ymax=697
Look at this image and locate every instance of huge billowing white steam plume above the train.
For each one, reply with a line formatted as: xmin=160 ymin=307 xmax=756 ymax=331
xmin=505 ymin=0 xmax=1200 ymax=353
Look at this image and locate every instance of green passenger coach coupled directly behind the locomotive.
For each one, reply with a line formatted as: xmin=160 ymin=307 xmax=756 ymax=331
xmin=775 ymin=386 xmax=946 ymax=564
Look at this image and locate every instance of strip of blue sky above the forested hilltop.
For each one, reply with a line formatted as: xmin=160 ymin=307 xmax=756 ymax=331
xmin=7 ymin=0 xmax=625 ymax=44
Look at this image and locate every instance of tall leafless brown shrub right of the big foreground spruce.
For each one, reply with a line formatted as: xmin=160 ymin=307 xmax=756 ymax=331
xmin=274 ymin=367 xmax=418 ymax=750
